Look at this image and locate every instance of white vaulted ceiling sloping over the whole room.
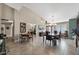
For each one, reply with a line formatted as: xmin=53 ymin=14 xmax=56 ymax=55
xmin=7 ymin=3 xmax=79 ymax=22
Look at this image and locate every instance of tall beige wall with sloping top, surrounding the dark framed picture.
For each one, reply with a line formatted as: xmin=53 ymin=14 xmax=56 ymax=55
xmin=15 ymin=7 xmax=44 ymax=35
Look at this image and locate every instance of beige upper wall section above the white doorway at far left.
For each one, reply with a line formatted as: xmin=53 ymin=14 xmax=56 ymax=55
xmin=2 ymin=4 xmax=14 ymax=20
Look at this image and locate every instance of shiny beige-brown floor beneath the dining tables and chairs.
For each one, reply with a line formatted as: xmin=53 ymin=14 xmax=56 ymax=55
xmin=6 ymin=37 xmax=78 ymax=55
